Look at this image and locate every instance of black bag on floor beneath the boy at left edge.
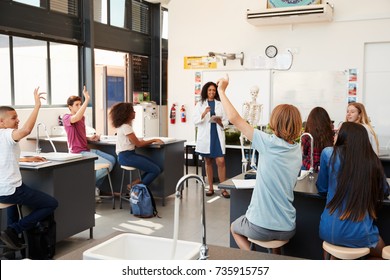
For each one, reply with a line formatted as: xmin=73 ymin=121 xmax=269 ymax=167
xmin=26 ymin=214 xmax=56 ymax=260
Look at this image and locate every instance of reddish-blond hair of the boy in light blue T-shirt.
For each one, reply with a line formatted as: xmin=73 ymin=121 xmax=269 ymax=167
xmin=270 ymin=104 xmax=302 ymax=143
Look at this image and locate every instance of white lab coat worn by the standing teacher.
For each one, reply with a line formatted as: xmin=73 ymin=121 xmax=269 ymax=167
xmin=192 ymin=100 xmax=229 ymax=154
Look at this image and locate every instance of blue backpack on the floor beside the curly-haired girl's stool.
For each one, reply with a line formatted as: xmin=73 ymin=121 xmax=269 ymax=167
xmin=130 ymin=184 xmax=157 ymax=218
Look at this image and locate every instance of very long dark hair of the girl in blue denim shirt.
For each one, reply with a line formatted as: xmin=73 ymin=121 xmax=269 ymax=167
xmin=326 ymin=122 xmax=385 ymax=222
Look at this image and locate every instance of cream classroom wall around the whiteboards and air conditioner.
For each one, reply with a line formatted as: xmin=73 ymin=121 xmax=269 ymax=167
xmin=168 ymin=0 xmax=390 ymax=144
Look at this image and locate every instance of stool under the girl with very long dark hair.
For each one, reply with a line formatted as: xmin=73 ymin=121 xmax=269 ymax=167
xmin=322 ymin=241 xmax=370 ymax=260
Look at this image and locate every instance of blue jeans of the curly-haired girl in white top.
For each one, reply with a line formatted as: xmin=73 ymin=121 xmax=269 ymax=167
xmin=118 ymin=150 xmax=161 ymax=186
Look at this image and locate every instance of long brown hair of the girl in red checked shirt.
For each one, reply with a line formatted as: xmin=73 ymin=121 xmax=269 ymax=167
xmin=305 ymin=107 xmax=333 ymax=151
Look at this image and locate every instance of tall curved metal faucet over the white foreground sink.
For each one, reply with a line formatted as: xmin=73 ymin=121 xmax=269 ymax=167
xmin=176 ymin=174 xmax=209 ymax=260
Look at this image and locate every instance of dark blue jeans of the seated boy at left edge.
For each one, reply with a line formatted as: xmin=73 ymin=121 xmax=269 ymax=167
xmin=0 ymin=183 xmax=58 ymax=233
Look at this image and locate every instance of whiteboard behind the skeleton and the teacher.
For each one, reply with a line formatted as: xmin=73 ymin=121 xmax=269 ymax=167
xmin=202 ymin=70 xmax=271 ymax=125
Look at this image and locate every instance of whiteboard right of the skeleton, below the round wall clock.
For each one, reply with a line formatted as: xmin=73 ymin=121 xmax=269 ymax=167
xmin=271 ymin=71 xmax=348 ymax=123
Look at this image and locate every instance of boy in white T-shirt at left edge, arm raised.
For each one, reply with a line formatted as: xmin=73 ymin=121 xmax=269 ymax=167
xmin=0 ymin=88 xmax=58 ymax=250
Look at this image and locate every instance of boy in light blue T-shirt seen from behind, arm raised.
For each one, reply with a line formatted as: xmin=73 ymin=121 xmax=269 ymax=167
xmin=217 ymin=77 xmax=302 ymax=253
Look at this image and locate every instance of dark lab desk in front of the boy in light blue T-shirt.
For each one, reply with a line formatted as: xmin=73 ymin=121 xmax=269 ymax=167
xmin=218 ymin=174 xmax=390 ymax=260
